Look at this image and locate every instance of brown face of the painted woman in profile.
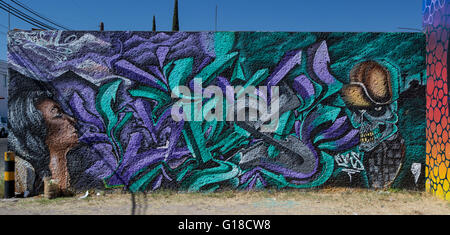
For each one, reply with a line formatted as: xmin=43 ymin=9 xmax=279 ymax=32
xmin=36 ymin=99 xmax=78 ymax=151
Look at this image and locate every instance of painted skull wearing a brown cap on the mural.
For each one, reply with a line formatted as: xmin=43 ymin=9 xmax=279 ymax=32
xmin=342 ymin=61 xmax=398 ymax=152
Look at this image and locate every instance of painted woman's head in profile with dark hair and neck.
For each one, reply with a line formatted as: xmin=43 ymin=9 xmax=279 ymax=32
xmin=8 ymin=78 xmax=78 ymax=196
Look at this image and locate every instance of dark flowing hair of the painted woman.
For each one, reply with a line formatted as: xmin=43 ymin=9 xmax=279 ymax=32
xmin=8 ymin=89 xmax=53 ymax=192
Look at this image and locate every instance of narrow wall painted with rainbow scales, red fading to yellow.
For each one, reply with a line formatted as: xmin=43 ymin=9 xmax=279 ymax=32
xmin=423 ymin=0 xmax=450 ymax=200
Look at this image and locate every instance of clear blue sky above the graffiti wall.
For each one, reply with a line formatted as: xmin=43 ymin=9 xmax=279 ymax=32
xmin=0 ymin=0 xmax=422 ymax=59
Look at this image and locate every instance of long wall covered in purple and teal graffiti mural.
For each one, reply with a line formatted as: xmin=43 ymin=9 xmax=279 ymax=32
xmin=8 ymin=31 xmax=425 ymax=196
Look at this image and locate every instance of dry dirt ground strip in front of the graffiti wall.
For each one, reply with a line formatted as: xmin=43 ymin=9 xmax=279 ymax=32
xmin=0 ymin=188 xmax=450 ymax=215
